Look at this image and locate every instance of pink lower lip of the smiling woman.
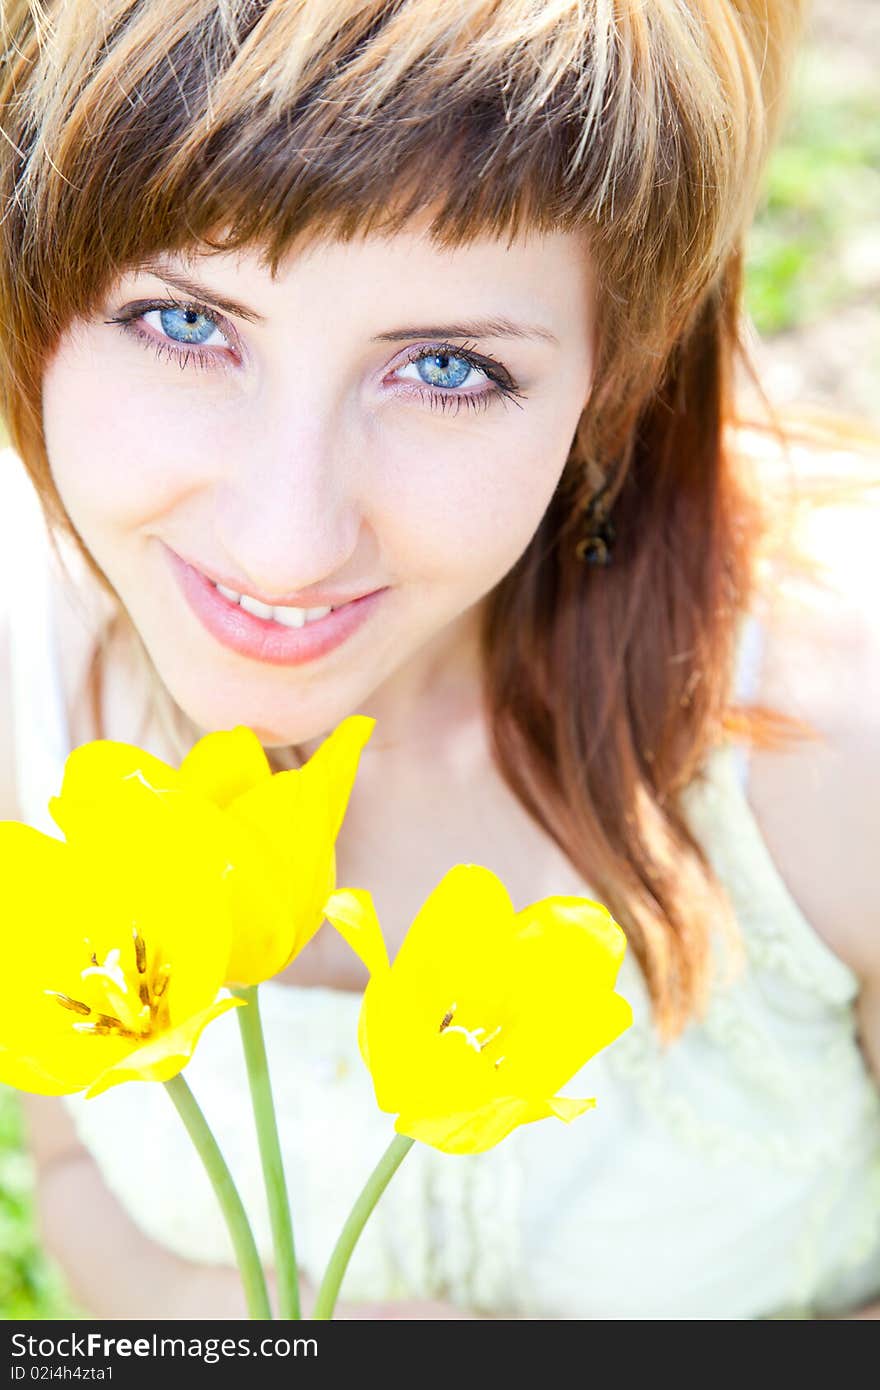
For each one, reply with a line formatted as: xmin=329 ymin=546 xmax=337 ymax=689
xmin=167 ymin=548 xmax=388 ymax=666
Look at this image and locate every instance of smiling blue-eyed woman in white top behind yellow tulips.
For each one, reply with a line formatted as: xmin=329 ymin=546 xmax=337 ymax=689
xmin=0 ymin=0 xmax=880 ymax=1318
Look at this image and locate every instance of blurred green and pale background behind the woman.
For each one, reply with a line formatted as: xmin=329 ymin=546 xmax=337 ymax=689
xmin=0 ymin=0 xmax=880 ymax=1319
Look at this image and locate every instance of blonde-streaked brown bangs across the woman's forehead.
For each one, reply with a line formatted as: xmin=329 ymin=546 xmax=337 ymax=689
xmin=5 ymin=0 xmax=750 ymax=325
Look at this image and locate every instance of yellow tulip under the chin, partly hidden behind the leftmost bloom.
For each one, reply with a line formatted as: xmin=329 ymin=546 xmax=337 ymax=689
xmin=49 ymin=714 xmax=375 ymax=986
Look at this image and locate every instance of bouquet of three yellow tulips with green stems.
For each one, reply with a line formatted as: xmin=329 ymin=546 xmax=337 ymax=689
xmin=0 ymin=716 xmax=631 ymax=1319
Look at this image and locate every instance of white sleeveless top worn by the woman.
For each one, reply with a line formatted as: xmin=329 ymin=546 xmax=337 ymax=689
xmin=0 ymin=452 xmax=880 ymax=1319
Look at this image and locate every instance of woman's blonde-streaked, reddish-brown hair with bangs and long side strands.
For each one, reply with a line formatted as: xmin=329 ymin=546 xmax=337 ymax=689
xmin=0 ymin=0 xmax=823 ymax=1037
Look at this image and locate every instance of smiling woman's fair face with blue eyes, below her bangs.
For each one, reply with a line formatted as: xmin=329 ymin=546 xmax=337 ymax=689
xmin=43 ymin=222 xmax=594 ymax=746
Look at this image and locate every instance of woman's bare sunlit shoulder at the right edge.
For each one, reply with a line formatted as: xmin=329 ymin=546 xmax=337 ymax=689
xmin=749 ymin=460 xmax=880 ymax=984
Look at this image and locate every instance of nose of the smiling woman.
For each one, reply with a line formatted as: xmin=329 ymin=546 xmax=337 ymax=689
xmin=217 ymin=405 xmax=370 ymax=599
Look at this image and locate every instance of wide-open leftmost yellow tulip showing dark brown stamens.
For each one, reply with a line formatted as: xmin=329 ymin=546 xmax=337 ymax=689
xmin=0 ymin=780 xmax=241 ymax=1095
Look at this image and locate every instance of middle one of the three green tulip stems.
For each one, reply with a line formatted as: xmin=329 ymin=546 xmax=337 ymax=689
xmin=232 ymin=984 xmax=300 ymax=1318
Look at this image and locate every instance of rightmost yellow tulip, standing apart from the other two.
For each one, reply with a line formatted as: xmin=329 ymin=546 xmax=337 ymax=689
xmin=324 ymin=865 xmax=633 ymax=1154
